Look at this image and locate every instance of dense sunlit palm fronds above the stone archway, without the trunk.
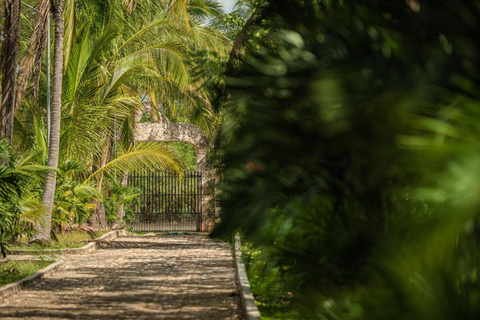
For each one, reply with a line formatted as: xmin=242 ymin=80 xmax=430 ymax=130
xmin=61 ymin=1 xmax=228 ymax=161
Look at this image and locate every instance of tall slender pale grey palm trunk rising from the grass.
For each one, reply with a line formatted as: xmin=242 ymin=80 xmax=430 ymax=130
xmin=37 ymin=0 xmax=64 ymax=240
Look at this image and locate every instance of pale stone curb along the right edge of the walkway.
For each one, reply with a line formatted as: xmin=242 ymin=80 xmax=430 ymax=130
xmin=234 ymin=235 xmax=261 ymax=320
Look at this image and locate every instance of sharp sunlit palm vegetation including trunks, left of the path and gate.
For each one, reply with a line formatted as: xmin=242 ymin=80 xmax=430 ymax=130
xmin=0 ymin=0 xmax=231 ymax=255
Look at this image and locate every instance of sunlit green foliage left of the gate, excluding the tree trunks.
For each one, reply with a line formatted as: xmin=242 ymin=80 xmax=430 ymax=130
xmin=0 ymin=0 xmax=231 ymax=248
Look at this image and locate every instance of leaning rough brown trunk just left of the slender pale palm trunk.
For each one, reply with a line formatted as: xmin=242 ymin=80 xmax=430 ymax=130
xmin=15 ymin=0 xmax=50 ymax=110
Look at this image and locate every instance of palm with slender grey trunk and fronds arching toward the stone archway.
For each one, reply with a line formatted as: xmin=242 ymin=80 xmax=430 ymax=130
xmin=18 ymin=1 xmax=229 ymax=239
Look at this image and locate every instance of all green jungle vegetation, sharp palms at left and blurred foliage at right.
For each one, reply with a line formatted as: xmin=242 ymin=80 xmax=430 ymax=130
xmin=0 ymin=0 xmax=480 ymax=320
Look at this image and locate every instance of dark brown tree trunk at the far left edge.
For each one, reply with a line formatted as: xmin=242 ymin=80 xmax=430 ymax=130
xmin=0 ymin=0 xmax=21 ymax=143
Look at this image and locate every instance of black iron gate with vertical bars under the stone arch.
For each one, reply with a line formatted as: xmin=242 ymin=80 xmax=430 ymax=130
xmin=127 ymin=170 xmax=202 ymax=231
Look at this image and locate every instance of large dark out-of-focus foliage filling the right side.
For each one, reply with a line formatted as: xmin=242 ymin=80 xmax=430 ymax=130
xmin=213 ymin=0 xmax=480 ymax=320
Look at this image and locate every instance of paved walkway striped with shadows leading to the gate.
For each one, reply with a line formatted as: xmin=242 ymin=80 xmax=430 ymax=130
xmin=0 ymin=235 xmax=242 ymax=320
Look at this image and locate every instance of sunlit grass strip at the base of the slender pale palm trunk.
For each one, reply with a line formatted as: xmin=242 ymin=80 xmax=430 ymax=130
xmin=9 ymin=231 xmax=106 ymax=251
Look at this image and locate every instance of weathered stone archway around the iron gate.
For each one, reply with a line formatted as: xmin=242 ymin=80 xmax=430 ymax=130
xmin=135 ymin=109 xmax=215 ymax=231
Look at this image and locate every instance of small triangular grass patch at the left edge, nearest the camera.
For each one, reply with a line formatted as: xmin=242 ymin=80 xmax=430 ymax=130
xmin=0 ymin=260 xmax=52 ymax=286
